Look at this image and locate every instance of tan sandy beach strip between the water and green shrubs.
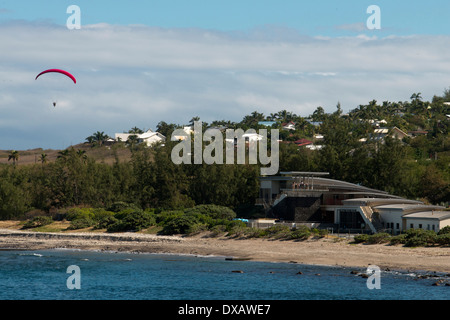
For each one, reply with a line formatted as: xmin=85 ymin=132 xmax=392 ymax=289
xmin=0 ymin=228 xmax=450 ymax=273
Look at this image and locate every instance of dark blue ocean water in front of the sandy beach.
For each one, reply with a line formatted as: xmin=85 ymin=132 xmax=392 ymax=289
xmin=0 ymin=250 xmax=450 ymax=300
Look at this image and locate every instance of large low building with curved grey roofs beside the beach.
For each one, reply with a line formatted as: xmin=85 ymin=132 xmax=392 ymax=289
xmin=257 ymin=172 xmax=450 ymax=234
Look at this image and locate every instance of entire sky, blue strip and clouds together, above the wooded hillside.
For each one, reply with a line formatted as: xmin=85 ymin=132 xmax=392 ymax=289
xmin=0 ymin=0 xmax=450 ymax=150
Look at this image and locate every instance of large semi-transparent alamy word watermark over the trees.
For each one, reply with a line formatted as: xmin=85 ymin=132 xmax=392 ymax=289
xmin=171 ymin=121 xmax=279 ymax=175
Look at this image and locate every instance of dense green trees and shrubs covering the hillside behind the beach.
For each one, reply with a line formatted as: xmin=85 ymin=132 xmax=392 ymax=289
xmin=0 ymin=90 xmax=450 ymax=237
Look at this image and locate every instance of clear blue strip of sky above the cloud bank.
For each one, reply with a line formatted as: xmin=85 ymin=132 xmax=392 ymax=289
xmin=0 ymin=0 xmax=450 ymax=36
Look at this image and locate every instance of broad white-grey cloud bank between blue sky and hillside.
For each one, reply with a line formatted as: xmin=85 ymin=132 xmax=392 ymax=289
xmin=0 ymin=23 xmax=450 ymax=149
